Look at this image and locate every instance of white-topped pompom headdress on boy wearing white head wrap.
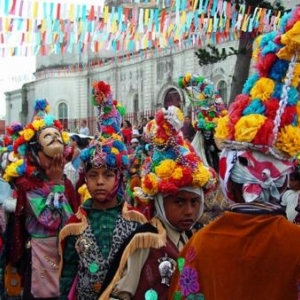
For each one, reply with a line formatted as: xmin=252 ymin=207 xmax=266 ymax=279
xmin=134 ymin=106 xmax=216 ymax=199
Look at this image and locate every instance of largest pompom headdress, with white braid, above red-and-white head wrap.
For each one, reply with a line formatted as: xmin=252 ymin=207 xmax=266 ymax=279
xmin=215 ymin=7 xmax=300 ymax=159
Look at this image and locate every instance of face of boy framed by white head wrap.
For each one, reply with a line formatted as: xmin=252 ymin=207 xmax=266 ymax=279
xmin=164 ymin=191 xmax=202 ymax=231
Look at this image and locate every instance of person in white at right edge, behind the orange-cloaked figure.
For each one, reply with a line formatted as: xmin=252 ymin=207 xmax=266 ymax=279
xmin=280 ymin=159 xmax=300 ymax=222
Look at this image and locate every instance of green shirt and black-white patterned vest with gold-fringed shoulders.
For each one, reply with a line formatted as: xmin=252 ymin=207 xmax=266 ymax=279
xmin=60 ymin=199 xmax=145 ymax=300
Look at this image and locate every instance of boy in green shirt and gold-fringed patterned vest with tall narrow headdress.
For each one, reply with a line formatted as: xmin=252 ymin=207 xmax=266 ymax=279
xmin=60 ymin=81 xmax=146 ymax=300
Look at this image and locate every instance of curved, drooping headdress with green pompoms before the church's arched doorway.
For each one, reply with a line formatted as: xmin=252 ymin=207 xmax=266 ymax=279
xmin=178 ymin=73 xmax=227 ymax=131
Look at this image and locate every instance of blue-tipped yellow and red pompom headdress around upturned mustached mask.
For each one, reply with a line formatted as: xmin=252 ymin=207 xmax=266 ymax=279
xmin=3 ymin=99 xmax=69 ymax=181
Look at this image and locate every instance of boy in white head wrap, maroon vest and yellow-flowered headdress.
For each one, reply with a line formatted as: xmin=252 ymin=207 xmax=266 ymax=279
xmin=99 ymin=106 xmax=213 ymax=300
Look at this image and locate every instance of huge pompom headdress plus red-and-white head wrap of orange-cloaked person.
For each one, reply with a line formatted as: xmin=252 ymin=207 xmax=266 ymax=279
xmin=215 ymin=7 xmax=300 ymax=202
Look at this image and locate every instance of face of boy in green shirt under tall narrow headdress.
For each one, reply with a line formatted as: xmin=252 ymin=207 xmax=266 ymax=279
xmin=86 ymin=168 xmax=116 ymax=203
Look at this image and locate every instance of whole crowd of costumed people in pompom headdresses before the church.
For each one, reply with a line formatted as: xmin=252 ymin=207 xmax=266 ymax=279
xmin=0 ymin=8 xmax=300 ymax=300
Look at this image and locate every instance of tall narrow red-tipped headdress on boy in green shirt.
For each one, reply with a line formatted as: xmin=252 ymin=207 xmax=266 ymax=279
xmin=80 ymin=81 xmax=129 ymax=170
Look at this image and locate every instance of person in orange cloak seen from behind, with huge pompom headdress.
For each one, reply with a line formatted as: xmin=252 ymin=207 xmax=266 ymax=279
xmin=168 ymin=7 xmax=300 ymax=300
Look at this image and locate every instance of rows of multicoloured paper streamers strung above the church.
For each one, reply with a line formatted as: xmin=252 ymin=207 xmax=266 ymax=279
xmin=0 ymin=0 xmax=282 ymax=57
